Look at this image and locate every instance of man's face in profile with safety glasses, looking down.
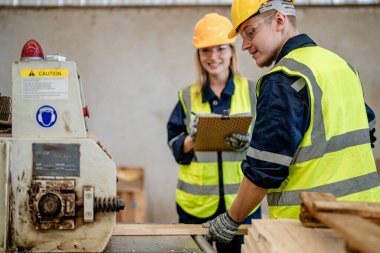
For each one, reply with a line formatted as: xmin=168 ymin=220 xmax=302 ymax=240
xmin=239 ymin=12 xmax=282 ymax=68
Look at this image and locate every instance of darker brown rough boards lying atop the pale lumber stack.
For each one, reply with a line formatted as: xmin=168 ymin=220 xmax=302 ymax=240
xmin=300 ymin=192 xmax=380 ymax=253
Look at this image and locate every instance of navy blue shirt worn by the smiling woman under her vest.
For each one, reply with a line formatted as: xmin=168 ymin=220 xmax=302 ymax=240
xmin=167 ymin=73 xmax=235 ymax=165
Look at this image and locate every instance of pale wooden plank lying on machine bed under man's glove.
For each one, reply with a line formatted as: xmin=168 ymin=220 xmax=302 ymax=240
xmin=112 ymin=223 xmax=249 ymax=235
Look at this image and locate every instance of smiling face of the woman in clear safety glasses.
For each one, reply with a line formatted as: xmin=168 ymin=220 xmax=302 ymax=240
xmin=198 ymin=45 xmax=232 ymax=75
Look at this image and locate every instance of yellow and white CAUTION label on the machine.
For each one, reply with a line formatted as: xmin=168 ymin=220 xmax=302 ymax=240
xmin=20 ymin=69 xmax=69 ymax=100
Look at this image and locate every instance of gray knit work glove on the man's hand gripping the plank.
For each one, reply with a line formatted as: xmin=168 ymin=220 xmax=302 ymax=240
xmin=202 ymin=212 xmax=240 ymax=244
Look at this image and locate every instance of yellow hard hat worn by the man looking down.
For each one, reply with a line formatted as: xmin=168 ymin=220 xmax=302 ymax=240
xmin=228 ymin=0 xmax=295 ymax=38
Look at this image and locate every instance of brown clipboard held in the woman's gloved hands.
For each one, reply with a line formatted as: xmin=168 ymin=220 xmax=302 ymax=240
xmin=194 ymin=113 xmax=252 ymax=151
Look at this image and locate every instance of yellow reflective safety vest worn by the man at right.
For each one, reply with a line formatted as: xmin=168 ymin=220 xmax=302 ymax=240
xmin=256 ymin=46 xmax=380 ymax=218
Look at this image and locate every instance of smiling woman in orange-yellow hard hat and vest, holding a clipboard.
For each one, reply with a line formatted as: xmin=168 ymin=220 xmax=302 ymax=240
xmin=167 ymin=13 xmax=261 ymax=252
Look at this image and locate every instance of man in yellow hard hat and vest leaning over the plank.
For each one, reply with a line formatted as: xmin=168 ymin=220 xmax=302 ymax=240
xmin=204 ymin=0 xmax=380 ymax=243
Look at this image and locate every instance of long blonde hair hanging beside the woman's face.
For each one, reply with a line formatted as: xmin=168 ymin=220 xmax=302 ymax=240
xmin=194 ymin=44 xmax=240 ymax=95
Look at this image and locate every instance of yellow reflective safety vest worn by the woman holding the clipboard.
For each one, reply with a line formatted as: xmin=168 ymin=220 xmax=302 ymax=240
xmin=176 ymin=76 xmax=256 ymax=218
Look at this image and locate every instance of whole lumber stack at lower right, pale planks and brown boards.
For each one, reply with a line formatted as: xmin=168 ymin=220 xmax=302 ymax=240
xmin=242 ymin=192 xmax=380 ymax=253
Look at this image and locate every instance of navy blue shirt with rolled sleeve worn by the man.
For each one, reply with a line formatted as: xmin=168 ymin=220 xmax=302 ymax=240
xmin=242 ymin=34 xmax=375 ymax=189
